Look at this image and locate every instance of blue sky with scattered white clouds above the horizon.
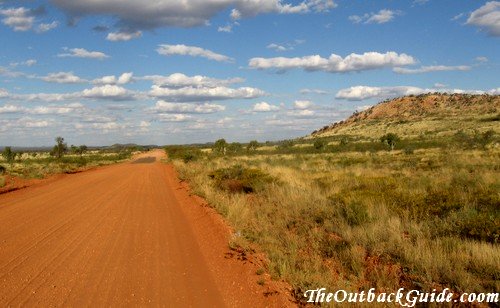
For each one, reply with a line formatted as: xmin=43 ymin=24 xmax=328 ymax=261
xmin=0 ymin=0 xmax=500 ymax=146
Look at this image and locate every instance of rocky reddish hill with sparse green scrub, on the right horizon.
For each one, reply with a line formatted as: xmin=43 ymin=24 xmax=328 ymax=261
xmin=311 ymin=93 xmax=500 ymax=138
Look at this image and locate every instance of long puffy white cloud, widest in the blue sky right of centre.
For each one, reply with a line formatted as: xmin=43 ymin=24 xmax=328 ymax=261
xmin=249 ymin=51 xmax=416 ymax=73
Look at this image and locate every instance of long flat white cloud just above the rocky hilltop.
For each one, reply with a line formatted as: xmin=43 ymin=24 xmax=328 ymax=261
xmin=335 ymin=86 xmax=495 ymax=101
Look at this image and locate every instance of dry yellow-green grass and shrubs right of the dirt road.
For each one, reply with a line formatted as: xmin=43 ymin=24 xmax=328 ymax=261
xmin=166 ymin=93 xmax=500 ymax=299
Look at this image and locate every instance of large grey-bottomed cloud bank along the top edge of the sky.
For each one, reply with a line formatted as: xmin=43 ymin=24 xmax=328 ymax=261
xmin=52 ymin=0 xmax=336 ymax=31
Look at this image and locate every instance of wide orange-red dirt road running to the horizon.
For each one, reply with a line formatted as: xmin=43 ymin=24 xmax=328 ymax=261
xmin=0 ymin=151 xmax=293 ymax=307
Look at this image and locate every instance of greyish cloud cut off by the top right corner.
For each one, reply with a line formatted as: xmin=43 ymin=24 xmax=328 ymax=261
xmin=466 ymin=1 xmax=500 ymax=36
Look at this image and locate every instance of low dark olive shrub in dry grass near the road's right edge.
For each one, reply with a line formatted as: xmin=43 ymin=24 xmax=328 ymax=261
xmin=209 ymin=165 xmax=274 ymax=193
